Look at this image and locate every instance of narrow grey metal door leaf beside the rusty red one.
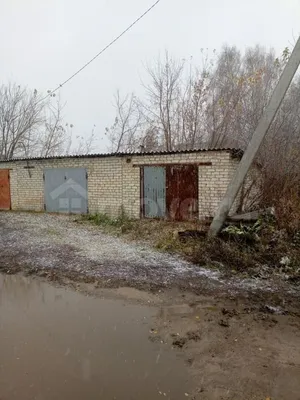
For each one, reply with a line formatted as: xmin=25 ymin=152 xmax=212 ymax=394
xmin=142 ymin=167 xmax=166 ymax=218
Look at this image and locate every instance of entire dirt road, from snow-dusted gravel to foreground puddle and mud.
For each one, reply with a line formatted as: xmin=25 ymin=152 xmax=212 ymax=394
xmin=0 ymin=213 xmax=300 ymax=400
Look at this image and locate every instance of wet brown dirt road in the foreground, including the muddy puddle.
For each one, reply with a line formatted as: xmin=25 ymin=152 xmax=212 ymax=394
xmin=0 ymin=274 xmax=300 ymax=400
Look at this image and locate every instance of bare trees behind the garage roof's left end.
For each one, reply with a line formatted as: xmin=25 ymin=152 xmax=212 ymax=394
xmin=0 ymin=83 xmax=95 ymax=160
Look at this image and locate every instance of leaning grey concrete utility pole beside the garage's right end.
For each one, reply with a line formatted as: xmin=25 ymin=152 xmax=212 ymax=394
xmin=208 ymin=37 xmax=300 ymax=236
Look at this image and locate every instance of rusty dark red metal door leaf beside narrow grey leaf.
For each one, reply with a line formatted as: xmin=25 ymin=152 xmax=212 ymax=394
xmin=166 ymin=165 xmax=198 ymax=221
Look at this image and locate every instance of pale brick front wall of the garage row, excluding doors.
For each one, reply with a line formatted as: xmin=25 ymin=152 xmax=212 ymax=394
xmin=0 ymin=149 xmax=239 ymax=219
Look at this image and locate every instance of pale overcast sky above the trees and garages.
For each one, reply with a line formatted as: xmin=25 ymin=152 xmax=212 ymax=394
xmin=0 ymin=0 xmax=300 ymax=151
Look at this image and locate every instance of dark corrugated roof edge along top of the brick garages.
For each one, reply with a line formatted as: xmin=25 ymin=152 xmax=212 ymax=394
xmin=0 ymin=148 xmax=243 ymax=163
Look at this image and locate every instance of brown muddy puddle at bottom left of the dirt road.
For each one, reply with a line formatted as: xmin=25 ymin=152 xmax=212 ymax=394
xmin=0 ymin=275 xmax=189 ymax=400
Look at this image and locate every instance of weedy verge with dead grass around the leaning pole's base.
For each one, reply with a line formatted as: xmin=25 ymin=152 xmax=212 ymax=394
xmin=78 ymin=214 xmax=300 ymax=282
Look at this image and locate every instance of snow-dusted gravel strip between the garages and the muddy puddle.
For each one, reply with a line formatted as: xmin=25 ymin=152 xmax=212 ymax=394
xmin=0 ymin=212 xmax=296 ymax=293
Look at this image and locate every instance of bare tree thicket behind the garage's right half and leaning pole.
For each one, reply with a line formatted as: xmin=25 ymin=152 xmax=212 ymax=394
xmin=107 ymin=46 xmax=300 ymax=226
